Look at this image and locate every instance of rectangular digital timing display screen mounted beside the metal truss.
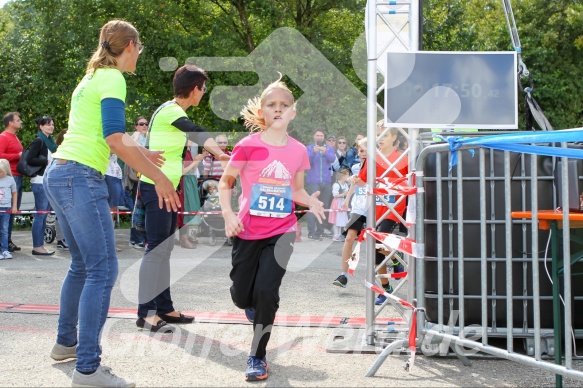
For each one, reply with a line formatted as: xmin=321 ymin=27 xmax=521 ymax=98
xmin=385 ymin=51 xmax=518 ymax=129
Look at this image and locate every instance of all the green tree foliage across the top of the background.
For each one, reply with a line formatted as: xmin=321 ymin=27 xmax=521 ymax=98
xmin=0 ymin=0 xmax=583 ymax=149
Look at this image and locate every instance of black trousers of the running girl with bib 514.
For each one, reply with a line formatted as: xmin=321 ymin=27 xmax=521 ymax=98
xmin=230 ymin=232 xmax=296 ymax=358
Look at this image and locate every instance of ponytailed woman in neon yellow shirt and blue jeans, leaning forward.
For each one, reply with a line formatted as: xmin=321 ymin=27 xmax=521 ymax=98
xmin=43 ymin=20 xmax=180 ymax=387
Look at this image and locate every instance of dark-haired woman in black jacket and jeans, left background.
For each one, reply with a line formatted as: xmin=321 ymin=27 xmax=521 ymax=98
xmin=26 ymin=116 xmax=57 ymax=256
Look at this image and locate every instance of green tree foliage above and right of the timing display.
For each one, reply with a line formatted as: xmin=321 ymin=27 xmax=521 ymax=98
xmin=423 ymin=0 xmax=583 ymax=129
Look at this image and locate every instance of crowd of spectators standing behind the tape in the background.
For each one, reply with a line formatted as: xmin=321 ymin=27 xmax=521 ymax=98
xmin=0 ymin=112 xmax=403 ymax=256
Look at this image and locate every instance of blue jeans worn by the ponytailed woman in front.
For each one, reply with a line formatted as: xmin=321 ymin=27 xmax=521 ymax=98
xmin=43 ymin=160 xmax=118 ymax=372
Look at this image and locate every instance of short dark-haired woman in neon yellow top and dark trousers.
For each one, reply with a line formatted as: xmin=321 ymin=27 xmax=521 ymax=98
xmin=136 ymin=65 xmax=229 ymax=332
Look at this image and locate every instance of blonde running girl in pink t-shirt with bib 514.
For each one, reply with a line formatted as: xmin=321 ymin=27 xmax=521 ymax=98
xmin=219 ymin=77 xmax=325 ymax=381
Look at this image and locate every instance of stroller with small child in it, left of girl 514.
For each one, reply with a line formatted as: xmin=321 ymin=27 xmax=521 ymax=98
xmin=197 ymin=178 xmax=233 ymax=246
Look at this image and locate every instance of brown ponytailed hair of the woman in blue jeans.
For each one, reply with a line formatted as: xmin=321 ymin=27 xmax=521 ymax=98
xmin=86 ymin=19 xmax=140 ymax=74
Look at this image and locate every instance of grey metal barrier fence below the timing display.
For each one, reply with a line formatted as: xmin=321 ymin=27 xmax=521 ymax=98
xmin=390 ymin=134 xmax=583 ymax=385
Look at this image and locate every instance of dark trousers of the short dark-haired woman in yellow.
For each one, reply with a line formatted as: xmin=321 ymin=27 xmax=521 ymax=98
xmin=138 ymin=182 xmax=178 ymax=318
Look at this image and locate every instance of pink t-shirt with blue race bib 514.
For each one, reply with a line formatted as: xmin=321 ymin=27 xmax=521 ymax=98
xmin=229 ymin=133 xmax=310 ymax=240
